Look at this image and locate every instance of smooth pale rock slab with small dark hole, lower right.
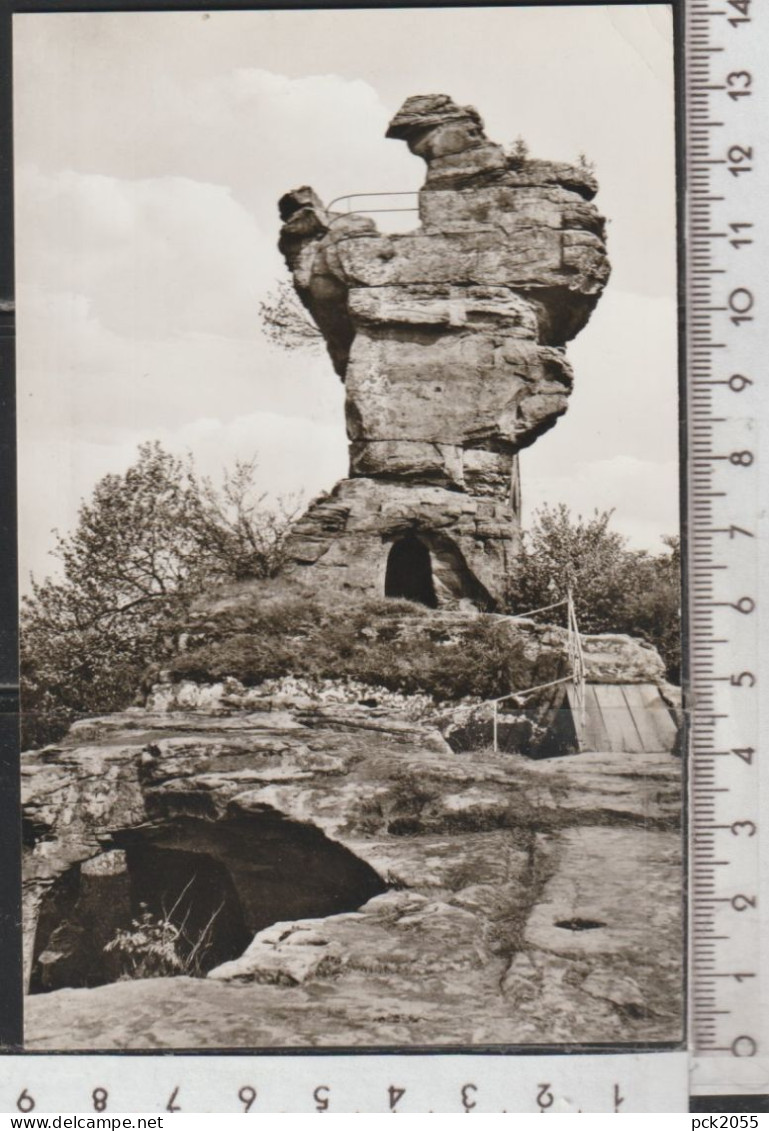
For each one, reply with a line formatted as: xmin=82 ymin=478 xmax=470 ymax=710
xmin=503 ymin=826 xmax=683 ymax=1044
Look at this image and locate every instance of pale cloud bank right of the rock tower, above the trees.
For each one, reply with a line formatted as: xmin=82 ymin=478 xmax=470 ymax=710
xmin=520 ymin=283 xmax=680 ymax=550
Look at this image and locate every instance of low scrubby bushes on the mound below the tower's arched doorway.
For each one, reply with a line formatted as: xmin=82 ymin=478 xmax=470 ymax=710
xmin=163 ymin=582 xmax=561 ymax=701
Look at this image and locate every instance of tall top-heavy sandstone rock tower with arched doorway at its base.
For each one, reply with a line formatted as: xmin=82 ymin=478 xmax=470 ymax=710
xmin=279 ymin=95 xmax=608 ymax=610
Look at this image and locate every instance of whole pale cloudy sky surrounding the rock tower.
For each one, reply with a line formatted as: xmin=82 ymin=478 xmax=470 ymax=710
xmin=14 ymin=5 xmax=677 ymax=581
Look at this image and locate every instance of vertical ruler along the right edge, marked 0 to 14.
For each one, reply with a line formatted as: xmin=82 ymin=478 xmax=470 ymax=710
xmin=683 ymin=0 xmax=769 ymax=1095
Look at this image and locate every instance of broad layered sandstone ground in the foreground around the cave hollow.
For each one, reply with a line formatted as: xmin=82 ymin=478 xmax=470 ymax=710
xmin=25 ymin=678 xmax=682 ymax=1050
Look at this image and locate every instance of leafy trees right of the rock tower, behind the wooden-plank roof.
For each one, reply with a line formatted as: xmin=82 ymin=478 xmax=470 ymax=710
xmin=508 ymin=503 xmax=681 ymax=681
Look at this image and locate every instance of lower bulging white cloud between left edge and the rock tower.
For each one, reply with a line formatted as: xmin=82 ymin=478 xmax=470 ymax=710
xmin=17 ymin=166 xmax=275 ymax=339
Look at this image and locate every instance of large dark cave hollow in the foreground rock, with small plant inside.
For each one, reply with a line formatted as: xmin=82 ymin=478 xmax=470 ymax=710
xmin=29 ymin=812 xmax=387 ymax=993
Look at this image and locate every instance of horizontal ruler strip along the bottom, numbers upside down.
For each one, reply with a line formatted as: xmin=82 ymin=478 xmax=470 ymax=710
xmin=0 ymin=1052 xmax=688 ymax=1112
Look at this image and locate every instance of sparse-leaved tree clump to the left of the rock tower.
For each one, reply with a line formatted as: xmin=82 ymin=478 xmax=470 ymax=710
xmin=21 ymin=443 xmax=294 ymax=745
